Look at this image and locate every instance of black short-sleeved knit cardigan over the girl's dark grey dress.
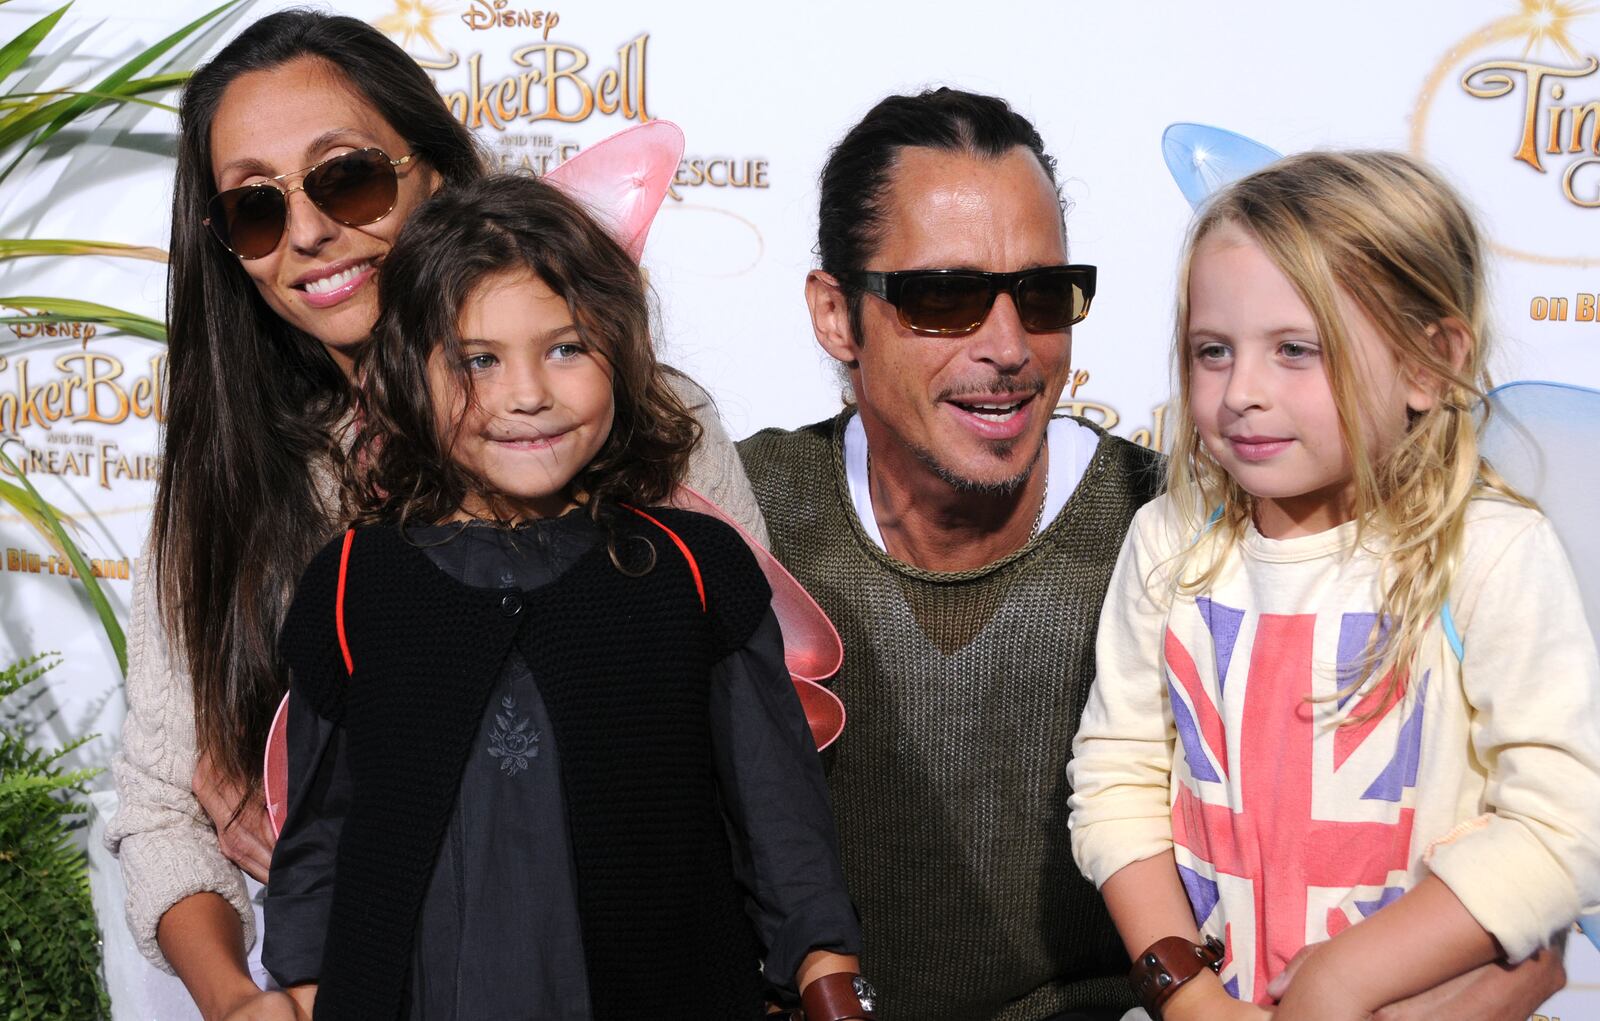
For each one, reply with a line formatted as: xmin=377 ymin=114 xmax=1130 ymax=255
xmin=280 ymin=509 xmax=771 ymax=1021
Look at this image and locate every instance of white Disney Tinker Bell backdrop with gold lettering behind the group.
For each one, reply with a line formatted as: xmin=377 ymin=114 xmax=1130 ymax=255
xmin=0 ymin=0 xmax=1600 ymax=1019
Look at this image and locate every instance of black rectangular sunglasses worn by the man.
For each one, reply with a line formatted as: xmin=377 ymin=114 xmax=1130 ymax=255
xmin=838 ymin=266 xmax=1094 ymax=336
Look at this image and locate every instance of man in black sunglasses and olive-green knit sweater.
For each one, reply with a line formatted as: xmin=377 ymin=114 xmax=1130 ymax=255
xmin=739 ymin=90 xmax=1160 ymax=1021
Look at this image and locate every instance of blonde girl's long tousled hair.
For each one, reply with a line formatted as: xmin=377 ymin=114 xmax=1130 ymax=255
xmin=1166 ymin=150 xmax=1528 ymax=715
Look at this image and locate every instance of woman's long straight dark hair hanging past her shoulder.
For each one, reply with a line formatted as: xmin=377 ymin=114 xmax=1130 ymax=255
xmin=154 ymin=11 xmax=483 ymax=791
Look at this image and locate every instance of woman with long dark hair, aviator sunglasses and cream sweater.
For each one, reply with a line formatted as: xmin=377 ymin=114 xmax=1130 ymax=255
xmin=107 ymin=11 xmax=765 ymax=1021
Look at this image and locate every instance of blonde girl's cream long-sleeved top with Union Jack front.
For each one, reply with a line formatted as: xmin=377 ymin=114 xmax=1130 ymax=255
xmin=1067 ymin=496 xmax=1600 ymax=1002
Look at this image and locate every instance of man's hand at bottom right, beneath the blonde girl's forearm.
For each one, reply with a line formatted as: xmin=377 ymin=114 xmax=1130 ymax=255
xmin=1267 ymin=941 xmax=1566 ymax=1021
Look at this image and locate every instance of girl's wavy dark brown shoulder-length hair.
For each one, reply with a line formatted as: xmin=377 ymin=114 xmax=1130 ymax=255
xmin=346 ymin=176 xmax=699 ymax=537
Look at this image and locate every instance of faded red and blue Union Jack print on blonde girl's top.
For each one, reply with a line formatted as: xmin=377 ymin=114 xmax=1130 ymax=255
xmin=1165 ymin=599 xmax=1429 ymax=1002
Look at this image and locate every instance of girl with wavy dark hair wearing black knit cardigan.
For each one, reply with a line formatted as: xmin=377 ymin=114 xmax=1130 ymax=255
xmin=264 ymin=178 xmax=859 ymax=1019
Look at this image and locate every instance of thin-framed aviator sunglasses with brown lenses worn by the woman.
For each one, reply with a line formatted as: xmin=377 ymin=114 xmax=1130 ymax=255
xmin=205 ymin=147 xmax=414 ymax=259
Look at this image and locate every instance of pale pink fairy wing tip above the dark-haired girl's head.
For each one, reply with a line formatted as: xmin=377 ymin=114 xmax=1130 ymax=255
xmin=544 ymin=120 xmax=683 ymax=262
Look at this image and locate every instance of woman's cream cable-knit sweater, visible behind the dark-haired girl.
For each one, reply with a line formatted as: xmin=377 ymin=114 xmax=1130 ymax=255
xmin=106 ymin=374 xmax=768 ymax=971
